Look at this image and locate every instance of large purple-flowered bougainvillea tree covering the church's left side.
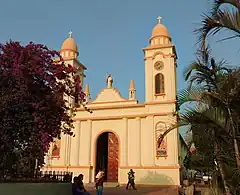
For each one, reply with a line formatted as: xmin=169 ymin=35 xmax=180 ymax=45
xmin=0 ymin=41 xmax=85 ymax=174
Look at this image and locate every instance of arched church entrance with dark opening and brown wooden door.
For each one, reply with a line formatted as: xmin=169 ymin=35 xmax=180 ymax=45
xmin=95 ymin=132 xmax=119 ymax=182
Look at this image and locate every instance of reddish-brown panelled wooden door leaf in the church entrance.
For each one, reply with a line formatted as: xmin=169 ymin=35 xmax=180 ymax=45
xmin=107 ymin=133 xmax=119 ymax=182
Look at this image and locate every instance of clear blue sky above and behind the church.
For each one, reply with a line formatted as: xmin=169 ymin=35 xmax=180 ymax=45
xmin=0 ymin=0 xmax=239 ymax=102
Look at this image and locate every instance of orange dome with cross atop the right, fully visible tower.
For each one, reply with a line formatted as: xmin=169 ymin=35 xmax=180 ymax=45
xmin=149 ymin=16 xmax=171 ymax=45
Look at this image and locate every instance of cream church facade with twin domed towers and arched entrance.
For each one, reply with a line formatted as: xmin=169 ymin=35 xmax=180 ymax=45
xmin=44 ymin=17 xmax=180 ymax=186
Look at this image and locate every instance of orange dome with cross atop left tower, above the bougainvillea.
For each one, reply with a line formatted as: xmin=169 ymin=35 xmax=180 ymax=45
xmin=60 ymin=32 xmax=78 ymax=58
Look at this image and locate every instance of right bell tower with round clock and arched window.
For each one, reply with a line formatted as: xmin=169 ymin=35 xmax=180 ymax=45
xmin=143 ymin=17 xmax=177 ymax=102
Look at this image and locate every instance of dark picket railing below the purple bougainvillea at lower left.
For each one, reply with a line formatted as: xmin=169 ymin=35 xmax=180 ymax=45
xmin=0 ymin=171 xmax=73 ymax=183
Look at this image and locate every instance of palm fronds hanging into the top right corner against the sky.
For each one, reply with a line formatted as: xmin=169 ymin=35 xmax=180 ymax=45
xmin=196 ymin=0 xmax=240 ymax=48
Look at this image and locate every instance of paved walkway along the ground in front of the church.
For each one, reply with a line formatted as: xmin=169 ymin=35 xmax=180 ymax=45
xmin=85 ymin=187 xmax=178 ymax=195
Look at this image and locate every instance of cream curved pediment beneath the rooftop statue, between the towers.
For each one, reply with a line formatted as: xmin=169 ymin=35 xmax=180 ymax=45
xmin=92 ymin=88 xmax=127 ymax=103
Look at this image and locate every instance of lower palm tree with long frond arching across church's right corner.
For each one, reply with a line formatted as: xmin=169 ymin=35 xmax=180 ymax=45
xmin=163 ymin=87 xmax=236 ymax=194
